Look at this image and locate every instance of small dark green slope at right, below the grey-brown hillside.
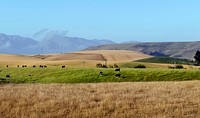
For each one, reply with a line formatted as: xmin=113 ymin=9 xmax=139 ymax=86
xmin=135 ymin=56 xmax=193 ymax=64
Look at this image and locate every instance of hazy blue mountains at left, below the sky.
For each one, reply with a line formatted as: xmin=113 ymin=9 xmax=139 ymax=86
xmin=0 ymin=33 xmax=114 ymax=54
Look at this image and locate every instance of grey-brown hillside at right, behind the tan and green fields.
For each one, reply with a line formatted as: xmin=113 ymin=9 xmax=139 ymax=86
xmin=86 ymin=41 xmax=200 ymax=59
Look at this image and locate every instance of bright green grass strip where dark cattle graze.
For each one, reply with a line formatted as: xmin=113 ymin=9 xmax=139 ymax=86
xmin=0 ymin=68 xmax=200 ymax=83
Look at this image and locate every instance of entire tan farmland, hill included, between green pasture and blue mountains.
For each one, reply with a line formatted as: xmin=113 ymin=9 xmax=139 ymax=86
xmin=0 ymin=50 xmax=151 ymax=68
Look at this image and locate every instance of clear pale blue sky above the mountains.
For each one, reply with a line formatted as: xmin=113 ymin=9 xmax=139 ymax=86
xmin=0 ymin=0 xmax=200 ymax=42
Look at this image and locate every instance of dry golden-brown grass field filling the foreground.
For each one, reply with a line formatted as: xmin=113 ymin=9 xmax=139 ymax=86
xmin=0 ymin=81 xmax=200 ymax=118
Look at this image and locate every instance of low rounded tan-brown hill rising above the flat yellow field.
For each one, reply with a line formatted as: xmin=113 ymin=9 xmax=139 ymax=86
xmin=33 ymin=50 xmax=151 ymax=61
